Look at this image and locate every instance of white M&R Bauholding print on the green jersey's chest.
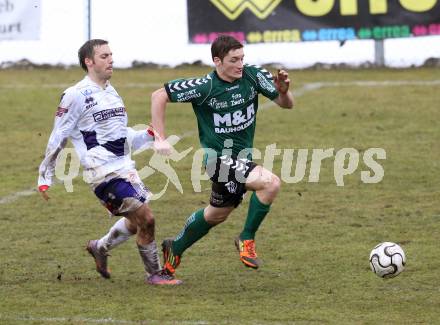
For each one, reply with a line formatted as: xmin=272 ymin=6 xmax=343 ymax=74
xmin=213 ymin=104 xmax=255 ymax=133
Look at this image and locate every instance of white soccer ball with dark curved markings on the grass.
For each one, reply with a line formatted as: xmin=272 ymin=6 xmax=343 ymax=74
xmin=370 ymin=242 xmax=406 ymax=278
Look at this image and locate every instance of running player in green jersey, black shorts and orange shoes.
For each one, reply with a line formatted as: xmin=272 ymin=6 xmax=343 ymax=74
xmin=151 ymin=35 xmax=293 ymax=275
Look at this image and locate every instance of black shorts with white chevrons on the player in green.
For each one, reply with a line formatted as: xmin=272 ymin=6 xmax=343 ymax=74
xmin=206 ymin=156 xmax=257 ymax=208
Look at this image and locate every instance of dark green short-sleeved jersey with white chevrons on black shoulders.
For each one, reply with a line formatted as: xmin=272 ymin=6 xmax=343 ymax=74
xmin=165 ymin=65 xmax=279 ymax=159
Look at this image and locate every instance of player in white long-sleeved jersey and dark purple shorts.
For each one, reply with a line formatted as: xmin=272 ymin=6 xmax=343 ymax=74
xmin=38 ymin=39 xmax=181 ymax=285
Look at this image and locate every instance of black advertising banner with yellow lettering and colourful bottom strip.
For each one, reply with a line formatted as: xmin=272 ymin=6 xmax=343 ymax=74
xmin=187 ymin=0 xmax=440 ymax=44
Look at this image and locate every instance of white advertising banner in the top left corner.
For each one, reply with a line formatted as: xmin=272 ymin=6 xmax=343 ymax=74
xmin=0 ymin=0 xmax=41 ymax=41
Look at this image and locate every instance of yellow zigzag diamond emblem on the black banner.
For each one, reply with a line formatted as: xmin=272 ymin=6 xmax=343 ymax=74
xmin=210 ymin=0 xmax=282 ymax=20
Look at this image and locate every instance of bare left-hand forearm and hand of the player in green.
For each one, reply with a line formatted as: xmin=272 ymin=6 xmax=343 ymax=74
xmin=151 ymin=88 xmax=171 ymax=155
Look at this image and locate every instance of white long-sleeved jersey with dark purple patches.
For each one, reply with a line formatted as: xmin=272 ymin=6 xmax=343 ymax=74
xmin=38 ymin=76 xmax=154 ymax=186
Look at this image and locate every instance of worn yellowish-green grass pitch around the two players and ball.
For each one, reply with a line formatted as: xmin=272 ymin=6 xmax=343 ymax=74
xmin=0 ymin=67 xmax=440 ymax=325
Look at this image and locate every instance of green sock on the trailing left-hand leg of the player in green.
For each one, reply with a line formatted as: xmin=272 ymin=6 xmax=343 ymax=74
xmin=173 ymin=209 xmax=213 ymax=256
